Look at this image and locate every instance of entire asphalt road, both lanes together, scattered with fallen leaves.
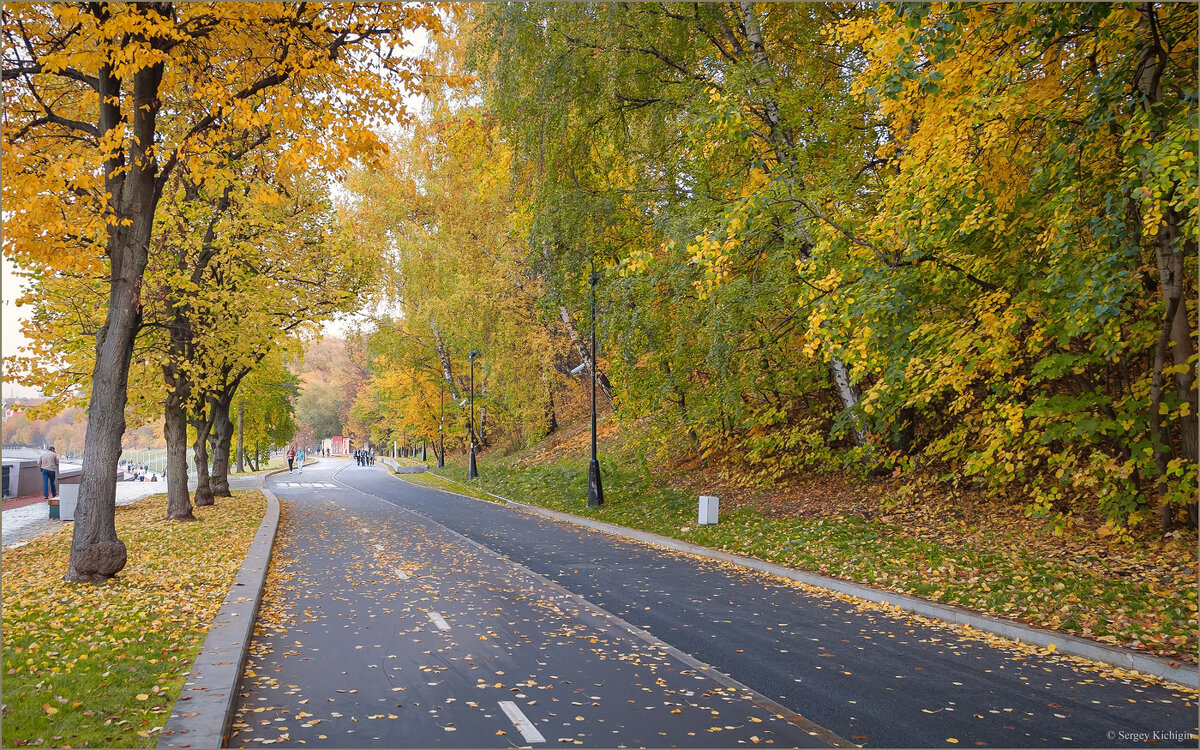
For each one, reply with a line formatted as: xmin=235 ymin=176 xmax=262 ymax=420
xmin=230 ymin=462 xmax=1196 ymax=748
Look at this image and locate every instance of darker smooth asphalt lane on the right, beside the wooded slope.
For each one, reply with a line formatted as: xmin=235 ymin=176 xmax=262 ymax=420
xmin=336 ymin=458 xmax=1196 ymax=746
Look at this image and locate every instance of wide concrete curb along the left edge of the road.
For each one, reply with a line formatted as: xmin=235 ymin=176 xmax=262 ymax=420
xmin=157 ymin=482 xmax=287 ymax=748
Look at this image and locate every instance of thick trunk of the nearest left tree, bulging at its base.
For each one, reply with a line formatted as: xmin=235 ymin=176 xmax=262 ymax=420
xmin=64 ymin=52 xmax=163 ymax=583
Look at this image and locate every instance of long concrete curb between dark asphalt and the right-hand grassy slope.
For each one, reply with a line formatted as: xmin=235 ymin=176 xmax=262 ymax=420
xmin=417 ymin=474 xmax=1200 ymax=689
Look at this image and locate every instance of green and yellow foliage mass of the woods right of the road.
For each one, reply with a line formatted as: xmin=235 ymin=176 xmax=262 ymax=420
xmin=352 ymin=4 xmax=1196 ymax=535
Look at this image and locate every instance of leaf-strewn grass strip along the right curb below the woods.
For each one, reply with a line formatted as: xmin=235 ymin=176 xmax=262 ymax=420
xmin=438 ymin=455 xmax=1198 ymax=661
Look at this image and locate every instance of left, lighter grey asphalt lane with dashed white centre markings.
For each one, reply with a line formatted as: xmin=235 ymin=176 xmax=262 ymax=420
xmin=228 ymin=462 xmax=848 ymax=748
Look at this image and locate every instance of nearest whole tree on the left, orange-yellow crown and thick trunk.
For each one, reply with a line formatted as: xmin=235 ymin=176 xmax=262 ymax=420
xmin=2 ymin=2 xmax=439 ymax=582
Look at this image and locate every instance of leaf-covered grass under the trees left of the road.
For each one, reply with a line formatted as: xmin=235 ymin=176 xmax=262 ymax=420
xmin=2 ymin=491 xmax=266 ymax=748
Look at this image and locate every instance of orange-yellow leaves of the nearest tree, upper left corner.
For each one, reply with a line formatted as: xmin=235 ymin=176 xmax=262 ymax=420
xmin=4 ymin=2 xmax=443 ymax=270
